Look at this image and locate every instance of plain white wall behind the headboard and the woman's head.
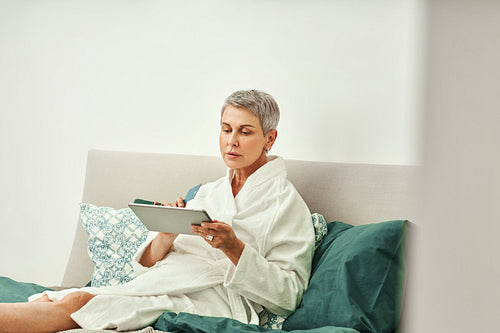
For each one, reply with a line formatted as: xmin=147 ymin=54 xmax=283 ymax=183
xmin=0 ymin=0 xmax=422 ymax=284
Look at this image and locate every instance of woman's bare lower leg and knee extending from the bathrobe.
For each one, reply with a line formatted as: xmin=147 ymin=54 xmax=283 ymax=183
xmin=0 ymin=292 xmax=94 ymax=333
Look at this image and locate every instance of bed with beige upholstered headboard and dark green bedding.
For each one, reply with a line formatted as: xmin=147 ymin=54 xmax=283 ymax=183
xmin=0 ymin=150 xmax=417 ymax=333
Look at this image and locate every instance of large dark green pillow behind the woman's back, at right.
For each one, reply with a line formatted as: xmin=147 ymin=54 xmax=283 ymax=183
xmin=283 ymin=220 xmax=406 ymax=333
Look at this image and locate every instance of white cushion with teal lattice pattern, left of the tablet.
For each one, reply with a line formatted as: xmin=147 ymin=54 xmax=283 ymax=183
xmin=80 ymin=203 xmax=148 ymax=287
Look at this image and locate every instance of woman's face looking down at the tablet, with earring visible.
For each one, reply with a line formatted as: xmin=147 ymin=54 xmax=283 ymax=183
xmin=219 ymin=105 xmax=277 ymax=176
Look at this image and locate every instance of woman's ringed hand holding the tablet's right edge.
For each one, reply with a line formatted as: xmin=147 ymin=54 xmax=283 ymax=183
xmin=191 ymin=220 xmax=245 ymax=265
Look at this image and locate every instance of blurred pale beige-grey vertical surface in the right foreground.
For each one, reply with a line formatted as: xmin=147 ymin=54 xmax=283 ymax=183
xmin=404 ymin=0 xmax=500 ymax=333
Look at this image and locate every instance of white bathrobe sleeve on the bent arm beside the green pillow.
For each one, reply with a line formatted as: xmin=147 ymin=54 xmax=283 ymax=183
xmin=224 ymin=188 xmax=314 ymax=315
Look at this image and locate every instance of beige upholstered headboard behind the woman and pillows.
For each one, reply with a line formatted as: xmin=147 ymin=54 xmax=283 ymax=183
xmin=63 ymin=150 xmax=416 ymax=286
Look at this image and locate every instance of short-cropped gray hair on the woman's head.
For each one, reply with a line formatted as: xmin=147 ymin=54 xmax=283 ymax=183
xmin=221 ymin=89 xmax=280 ymax=134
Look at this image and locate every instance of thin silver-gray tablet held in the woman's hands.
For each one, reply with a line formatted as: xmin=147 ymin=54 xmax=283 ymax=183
xmin=128 ymin=203 xmax=212 ymax=235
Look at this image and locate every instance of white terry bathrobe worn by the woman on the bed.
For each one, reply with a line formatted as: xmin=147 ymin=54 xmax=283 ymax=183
xmin=32 ymin=158 xmax=314 ymax=330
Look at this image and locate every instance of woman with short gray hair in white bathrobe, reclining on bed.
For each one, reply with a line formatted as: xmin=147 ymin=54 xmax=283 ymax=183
xmin=0 ymin=90 xmax=314 ymax=333
